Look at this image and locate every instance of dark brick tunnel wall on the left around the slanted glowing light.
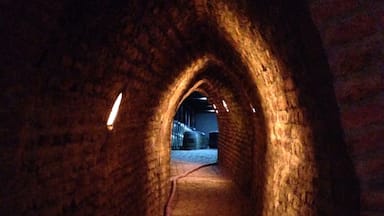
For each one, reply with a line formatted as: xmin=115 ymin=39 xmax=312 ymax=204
xmin=0 ymin=1 xmax=201 ymax=215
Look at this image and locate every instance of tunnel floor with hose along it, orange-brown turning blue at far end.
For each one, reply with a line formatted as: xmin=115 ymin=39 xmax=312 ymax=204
xmin=171 ymin=149 xmax=251 ymax=216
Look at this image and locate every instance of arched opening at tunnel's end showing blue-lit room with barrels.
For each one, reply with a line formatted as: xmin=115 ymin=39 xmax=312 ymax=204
xmin=171 ymin=91 xmax=219 ymax=176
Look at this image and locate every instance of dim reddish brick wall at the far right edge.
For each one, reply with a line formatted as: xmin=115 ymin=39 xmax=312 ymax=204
xmin=310 ymin=0 xmax=384 ymax=215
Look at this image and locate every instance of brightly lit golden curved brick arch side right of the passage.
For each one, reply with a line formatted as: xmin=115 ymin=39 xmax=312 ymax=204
xmin=204 ymin=1 xmax=335 ymax=215
